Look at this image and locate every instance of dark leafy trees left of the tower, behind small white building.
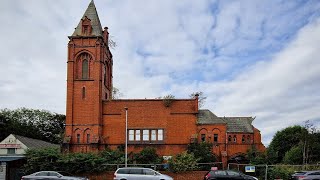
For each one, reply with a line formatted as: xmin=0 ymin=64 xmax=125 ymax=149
xmin=0 ymin=108 xmax=65 ymax=143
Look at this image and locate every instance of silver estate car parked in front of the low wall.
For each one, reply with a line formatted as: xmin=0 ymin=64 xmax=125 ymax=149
xmin=113 ymin=167 xmax=173 ymax=180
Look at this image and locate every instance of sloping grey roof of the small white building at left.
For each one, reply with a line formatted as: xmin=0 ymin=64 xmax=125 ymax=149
xmin=14 ymin=135 xmax=60 ymax=149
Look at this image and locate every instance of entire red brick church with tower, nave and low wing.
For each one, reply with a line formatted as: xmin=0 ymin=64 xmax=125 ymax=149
xmin=64 ymin=1 xmax=265 ymax=167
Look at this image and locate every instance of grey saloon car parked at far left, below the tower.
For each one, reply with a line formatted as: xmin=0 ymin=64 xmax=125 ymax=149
xmin=21 ymin=171 xmax=89 ymax=180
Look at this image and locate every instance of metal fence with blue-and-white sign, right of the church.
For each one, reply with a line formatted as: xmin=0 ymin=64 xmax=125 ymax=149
xmin=228 ymin=163 xmax=320 ymax=180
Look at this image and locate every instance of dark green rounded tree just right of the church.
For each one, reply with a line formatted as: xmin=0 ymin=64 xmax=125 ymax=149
xmin=267 ymin=126 xmax=307 ymax=164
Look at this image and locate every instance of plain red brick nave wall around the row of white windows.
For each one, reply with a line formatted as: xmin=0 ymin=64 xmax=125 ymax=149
xmin=103 ymin=99 xmax=197 ymax=155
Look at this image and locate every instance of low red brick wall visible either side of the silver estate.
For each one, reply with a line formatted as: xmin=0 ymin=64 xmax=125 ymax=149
xmin=86 ymin=171 xmax=207 ymax=180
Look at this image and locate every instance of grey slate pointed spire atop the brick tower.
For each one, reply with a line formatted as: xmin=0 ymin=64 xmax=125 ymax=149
xmin=72 ymin=0 xmax=103 ymax=36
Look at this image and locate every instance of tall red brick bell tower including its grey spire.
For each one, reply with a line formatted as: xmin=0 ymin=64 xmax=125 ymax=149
xmin=63 ymin=0 xmax=113 ymax=152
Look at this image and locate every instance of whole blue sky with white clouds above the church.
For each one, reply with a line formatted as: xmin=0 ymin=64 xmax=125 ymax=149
xmin=0 ymin=0 xmax=320 ymax=145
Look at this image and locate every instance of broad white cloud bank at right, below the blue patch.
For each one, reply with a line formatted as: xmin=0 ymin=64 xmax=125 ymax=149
xmin=200 ymin=18 xmax=320 ymax=143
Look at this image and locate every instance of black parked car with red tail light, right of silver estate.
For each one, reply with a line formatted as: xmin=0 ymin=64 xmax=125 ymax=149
xmin=203 ymin=170 xmax=258 ymax=180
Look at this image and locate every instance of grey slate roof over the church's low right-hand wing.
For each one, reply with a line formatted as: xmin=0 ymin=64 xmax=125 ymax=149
xmin=197 ymin=109 xmax=254 ymax=133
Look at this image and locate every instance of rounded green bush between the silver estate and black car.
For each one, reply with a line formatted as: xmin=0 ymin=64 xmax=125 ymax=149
xmin=169 ymin=151 xmax=198 ymax=172
